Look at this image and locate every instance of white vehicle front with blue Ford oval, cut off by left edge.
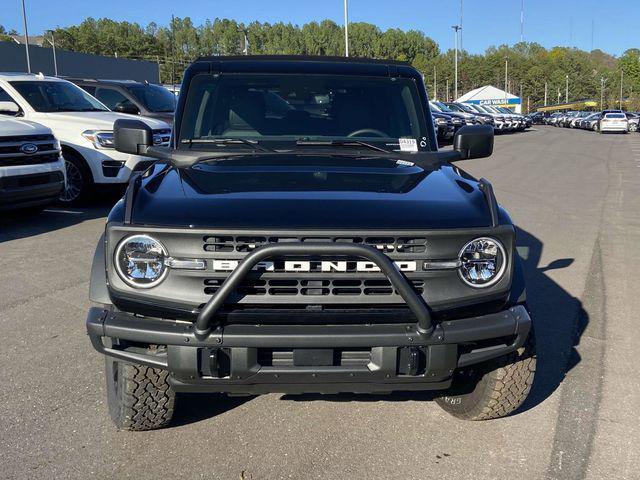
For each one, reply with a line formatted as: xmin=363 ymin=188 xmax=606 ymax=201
xmin=0 ymin=116 xmax=65 ymax=211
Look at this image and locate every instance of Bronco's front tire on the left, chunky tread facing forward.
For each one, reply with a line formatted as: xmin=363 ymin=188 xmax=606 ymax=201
xmin=105 ymin=357 xmax=176 ymax=431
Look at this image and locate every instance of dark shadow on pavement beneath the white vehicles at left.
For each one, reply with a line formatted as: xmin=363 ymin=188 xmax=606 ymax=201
xmin=0 ymin=191 xmax=122 ymax=243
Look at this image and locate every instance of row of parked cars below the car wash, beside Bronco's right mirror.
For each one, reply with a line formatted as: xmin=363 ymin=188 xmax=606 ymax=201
xmin=429 ymin=101 xmax=532 ymax=142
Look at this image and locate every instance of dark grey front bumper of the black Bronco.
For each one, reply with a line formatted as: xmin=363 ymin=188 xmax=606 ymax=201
xmin=87 ymin=305 xmax=531 ymax=394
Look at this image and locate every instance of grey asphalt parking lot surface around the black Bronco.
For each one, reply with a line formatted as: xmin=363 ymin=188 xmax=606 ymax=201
xmin=0 ymin=126 xmax=640 ymax=480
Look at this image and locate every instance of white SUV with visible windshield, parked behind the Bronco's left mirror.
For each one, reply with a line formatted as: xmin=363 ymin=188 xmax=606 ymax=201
xmin=0 ymin=73 xmax=171 ymax=203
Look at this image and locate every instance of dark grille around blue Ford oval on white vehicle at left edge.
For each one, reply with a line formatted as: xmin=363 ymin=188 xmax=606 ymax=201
xmin=0 ymin=135 xmax=60 ymax=167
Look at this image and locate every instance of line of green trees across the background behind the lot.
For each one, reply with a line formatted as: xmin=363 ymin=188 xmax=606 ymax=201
xmin=0 ymin=17 xmax=640 ymax=110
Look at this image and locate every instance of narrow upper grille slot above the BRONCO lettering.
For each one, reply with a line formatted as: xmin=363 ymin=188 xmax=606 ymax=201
xmin=203 ymin=235 xmax=427 ymax=254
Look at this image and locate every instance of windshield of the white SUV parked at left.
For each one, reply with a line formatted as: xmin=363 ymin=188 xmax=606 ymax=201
xmin=9 ymin=81 xmax=108 ymax=112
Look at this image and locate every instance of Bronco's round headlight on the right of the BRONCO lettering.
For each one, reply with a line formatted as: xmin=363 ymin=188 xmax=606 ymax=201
xmin=458 ymin=237 xmax=507 ymax=288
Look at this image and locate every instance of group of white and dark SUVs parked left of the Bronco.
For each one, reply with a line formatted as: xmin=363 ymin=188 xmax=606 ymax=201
xmin=0 ymin=73 xmax=176 ymax=210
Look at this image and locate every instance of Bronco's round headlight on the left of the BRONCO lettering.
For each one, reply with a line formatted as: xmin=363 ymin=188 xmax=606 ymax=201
xmin=114 ymin=235 xmax=168 ymax=288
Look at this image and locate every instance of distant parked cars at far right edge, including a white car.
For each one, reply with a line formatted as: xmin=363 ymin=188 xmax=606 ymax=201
xmin=542 ymin=110 xmax=640 ymax=133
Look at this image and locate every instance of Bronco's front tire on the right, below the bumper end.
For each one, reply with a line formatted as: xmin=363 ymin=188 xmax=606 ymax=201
xmin=436 ymin=331 xmax=536 ymax=420
